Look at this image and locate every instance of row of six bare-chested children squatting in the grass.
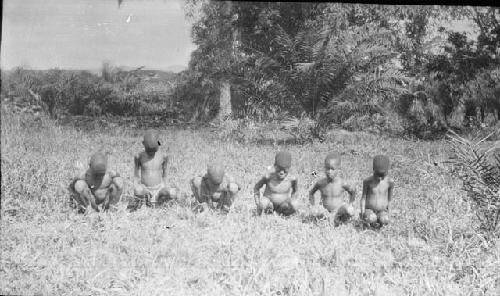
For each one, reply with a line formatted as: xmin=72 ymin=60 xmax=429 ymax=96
xmin=69 ymin=130 xmax=394 ymax=226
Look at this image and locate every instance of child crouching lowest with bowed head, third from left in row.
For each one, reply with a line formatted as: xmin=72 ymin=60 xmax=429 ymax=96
xmin=190 ymin=163 xmax=241 ymax=211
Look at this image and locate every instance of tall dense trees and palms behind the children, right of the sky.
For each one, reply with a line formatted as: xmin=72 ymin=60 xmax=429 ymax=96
xmin=175 ymin=0 xmax=500 ymax=136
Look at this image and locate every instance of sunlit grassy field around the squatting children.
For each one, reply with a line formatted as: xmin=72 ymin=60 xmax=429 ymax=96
xmin=0 ymin=112 xmax=500 ymax=295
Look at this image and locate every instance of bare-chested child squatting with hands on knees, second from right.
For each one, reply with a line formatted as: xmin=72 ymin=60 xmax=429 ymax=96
xmin=309 ymin=153 xmax=356 ymax=223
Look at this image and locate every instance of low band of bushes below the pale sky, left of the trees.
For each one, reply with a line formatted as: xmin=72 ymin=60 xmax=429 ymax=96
xmin=2 ymin=63 xmax=184 ymax=118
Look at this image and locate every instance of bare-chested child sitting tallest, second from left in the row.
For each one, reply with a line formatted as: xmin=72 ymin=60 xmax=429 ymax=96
xmin=128 ymin=130 xmax=178 ymax=211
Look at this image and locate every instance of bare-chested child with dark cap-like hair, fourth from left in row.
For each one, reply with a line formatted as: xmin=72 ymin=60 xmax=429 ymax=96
xmin=254 ymin=152 xmax=299 ymax=216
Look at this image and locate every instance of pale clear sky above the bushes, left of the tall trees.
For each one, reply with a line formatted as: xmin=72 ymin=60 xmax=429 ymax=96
xmin=0 ymin=0 xmax=196 ymax=71
